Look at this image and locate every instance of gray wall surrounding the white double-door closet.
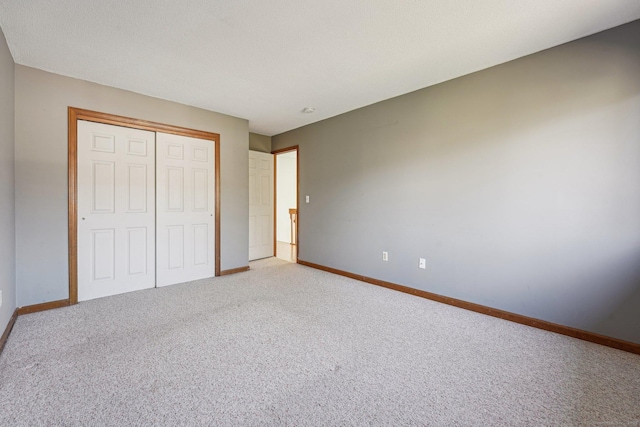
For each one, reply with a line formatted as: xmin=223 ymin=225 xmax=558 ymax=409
xmin=15 ymin=65 xmax=249 ymax=306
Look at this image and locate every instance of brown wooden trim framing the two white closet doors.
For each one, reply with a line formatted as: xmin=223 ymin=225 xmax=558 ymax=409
xmin=67 ymin=107 xmax=220 ymax=304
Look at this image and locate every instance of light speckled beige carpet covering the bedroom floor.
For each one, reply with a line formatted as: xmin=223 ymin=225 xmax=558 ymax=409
xmin=0 ymin=258 xmax=640 ymax=426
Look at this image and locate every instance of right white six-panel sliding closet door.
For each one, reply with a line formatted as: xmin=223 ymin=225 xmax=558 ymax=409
xmin=156 ymin=132 xmax=215 ymax=286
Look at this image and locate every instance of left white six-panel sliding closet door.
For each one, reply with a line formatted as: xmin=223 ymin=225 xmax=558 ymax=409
xmin=77 ymin=120 xmax=155 ymax=301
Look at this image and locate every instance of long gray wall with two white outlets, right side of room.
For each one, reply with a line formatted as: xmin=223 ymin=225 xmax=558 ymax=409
xmin=272 ymin=21 xmax=640 ymax=343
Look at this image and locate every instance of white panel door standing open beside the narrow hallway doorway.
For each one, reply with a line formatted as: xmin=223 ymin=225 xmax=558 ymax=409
xmin=249 ymin=151 xmax=274 ymax=261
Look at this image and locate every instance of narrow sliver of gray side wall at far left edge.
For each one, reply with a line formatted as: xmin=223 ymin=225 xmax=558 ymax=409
xmin=0 ymin=30 xmax=16 ymax=335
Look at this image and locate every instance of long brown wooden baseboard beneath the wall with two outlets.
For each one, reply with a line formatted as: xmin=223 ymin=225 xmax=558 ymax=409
xmin=298 ymin=260 xmax=640 ymax=354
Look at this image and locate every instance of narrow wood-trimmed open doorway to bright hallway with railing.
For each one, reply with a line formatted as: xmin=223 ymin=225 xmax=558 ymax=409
xmin=273 ymin=146 xmax=299 ymax=262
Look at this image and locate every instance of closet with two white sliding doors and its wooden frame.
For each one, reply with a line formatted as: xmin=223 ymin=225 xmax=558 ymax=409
xmin=69 ymin=107 xmax=220 ymax=304
